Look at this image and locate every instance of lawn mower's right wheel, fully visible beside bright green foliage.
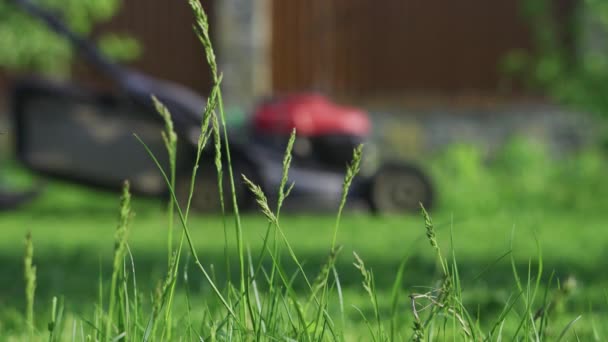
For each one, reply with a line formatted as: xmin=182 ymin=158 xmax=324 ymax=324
xmin=367 ymin=163 xmax=433 ymax=213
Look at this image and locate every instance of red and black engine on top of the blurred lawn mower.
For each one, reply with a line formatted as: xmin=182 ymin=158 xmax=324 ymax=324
xmin=253 ymin=94 xmax=371 ymax=167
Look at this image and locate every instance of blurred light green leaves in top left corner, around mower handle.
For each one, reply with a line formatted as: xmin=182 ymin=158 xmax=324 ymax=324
xmin=0 ymin=0 xmax=140 ymax=76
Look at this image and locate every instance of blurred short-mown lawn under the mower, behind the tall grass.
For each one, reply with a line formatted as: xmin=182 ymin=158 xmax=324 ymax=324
xmin=0 ymin=178 xmax=608 ymax=337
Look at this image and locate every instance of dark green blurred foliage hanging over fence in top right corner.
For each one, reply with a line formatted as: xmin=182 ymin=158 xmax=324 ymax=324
xmin=502 ymin=0 xmax=608 ymax=117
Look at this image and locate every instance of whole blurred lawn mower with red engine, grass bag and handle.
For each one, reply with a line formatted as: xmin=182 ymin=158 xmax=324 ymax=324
xmin=7 ymin=0 xmax=433 ymax=213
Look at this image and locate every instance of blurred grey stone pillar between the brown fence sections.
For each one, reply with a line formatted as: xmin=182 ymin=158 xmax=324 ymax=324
xmin=214 ymin=0 xmax=272 ymax=110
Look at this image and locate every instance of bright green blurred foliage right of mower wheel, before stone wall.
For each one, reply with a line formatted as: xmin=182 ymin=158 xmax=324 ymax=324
xmin=432 ymin=138 xmax=608 ymax=213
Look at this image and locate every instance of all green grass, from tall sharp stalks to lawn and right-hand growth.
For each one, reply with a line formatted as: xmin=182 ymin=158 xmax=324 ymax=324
xmin=0 ymin=0 xmax=608 ymax=341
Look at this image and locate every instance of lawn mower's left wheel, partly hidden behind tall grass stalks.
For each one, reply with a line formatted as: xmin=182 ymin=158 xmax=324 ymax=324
xmin=176 ymin=162 xmax=257 ymax=213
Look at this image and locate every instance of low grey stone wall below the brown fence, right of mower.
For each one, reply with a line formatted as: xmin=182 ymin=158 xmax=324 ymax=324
xmin=372 ymin=104 xmax=599 ymax=159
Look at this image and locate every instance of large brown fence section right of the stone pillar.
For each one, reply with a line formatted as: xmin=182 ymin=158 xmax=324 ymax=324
xmin=272 ymin=0 xmax=573 ymax=96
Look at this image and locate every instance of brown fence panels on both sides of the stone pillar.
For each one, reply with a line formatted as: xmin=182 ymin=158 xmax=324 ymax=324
xmin=0 ymin=0 xmax=576 ymax=101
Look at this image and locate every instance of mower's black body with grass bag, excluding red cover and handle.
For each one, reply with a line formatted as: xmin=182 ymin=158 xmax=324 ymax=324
xmin=12 ymin=80 xmax=432 ymax=211
